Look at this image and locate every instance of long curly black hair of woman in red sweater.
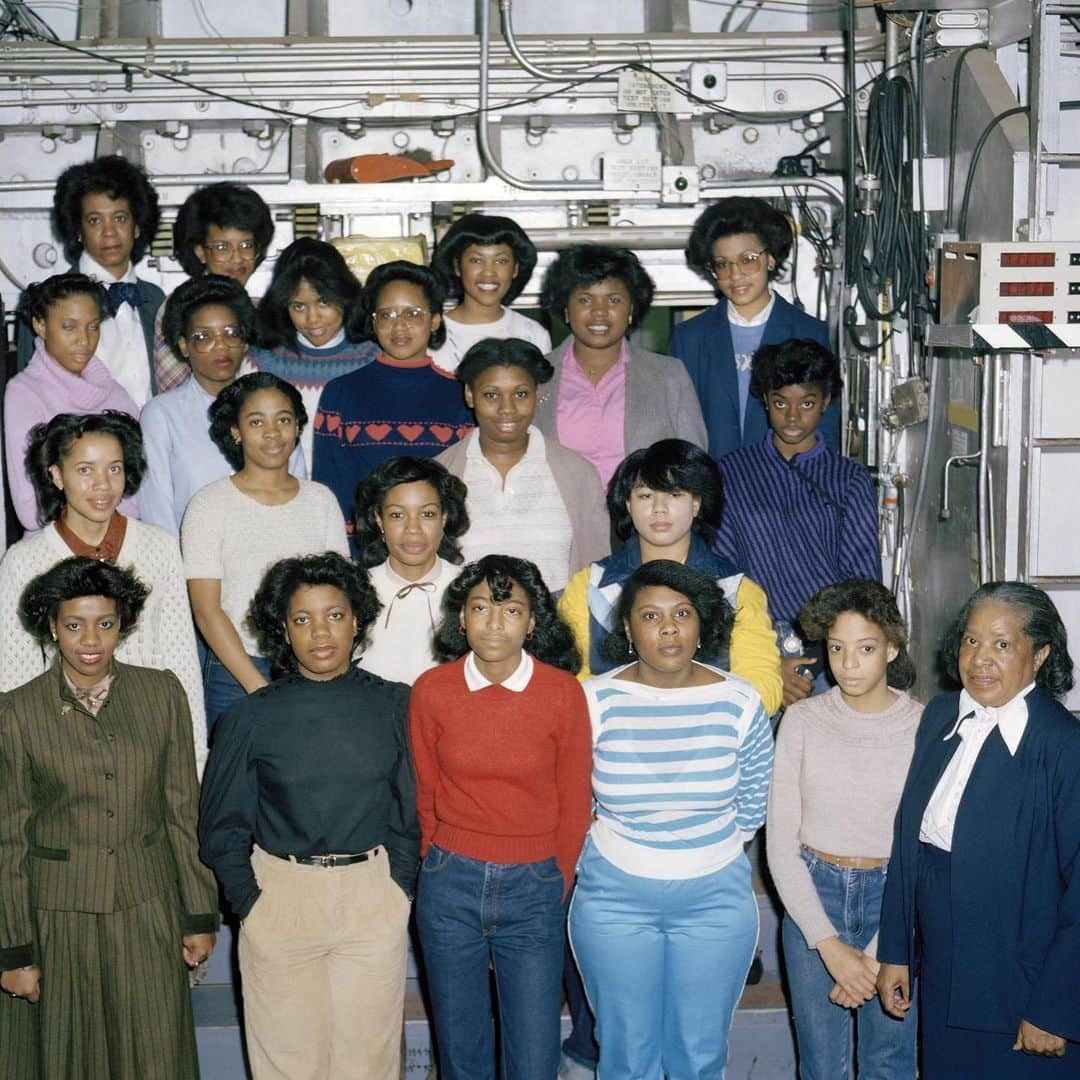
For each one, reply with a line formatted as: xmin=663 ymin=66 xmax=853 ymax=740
xmin=434 ymin=555 xmax=581 ymax=675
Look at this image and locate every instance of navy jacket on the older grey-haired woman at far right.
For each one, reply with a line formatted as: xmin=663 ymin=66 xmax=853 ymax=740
xmin=878 ymin=688 xmax=1080 ymax=1041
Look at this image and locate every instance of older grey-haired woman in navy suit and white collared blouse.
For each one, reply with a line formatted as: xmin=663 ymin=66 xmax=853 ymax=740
xmin=878 ymin=581 xmax=1080 ymax=1080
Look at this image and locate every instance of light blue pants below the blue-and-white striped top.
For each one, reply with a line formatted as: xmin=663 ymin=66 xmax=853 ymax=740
xmin=570 ymin=841 xmax=758 ymax=1080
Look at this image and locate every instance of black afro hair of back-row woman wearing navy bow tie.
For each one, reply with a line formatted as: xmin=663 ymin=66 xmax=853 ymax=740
xmin=52 ymin=153 xmax=161 ymax=264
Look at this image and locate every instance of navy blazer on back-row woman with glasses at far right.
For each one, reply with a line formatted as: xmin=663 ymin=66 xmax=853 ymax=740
xmin=667 ymin=296 xmax=840 ymax=458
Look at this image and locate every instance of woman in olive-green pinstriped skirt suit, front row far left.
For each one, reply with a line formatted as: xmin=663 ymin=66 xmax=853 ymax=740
xmin=0 ymin=557 xmax=218 ymax=1080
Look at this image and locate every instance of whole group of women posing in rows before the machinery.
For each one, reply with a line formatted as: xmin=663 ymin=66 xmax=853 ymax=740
xmin=0 ymin=159 xmax=1080 ymax=1080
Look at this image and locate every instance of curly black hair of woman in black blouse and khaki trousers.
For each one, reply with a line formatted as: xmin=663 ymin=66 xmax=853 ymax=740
xmin=245 ymin=551 xmax=382 ymax=675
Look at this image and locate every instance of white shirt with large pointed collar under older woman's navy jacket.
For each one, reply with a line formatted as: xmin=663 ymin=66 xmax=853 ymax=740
xmin=919 ymin=683 xmax=1035 ymax=851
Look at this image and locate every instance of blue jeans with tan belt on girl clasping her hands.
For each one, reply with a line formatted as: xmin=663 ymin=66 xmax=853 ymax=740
xmin=781 ymin=850 xmax=917 ymax=1080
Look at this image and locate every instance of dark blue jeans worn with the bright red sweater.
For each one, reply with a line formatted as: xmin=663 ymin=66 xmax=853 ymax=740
xmin=416 ymin=845 xmax=565 ymax=1080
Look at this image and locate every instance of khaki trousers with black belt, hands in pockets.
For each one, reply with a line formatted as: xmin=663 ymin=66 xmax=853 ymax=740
xmin=240 ymin=847 xmax=409 ymax=1080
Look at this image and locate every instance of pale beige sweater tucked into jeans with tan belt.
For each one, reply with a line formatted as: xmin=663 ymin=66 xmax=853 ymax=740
xmin=766 ymin=687 xmax=922 ymax=955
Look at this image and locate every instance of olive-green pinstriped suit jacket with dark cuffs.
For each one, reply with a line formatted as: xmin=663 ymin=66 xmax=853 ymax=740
xmin=0 ymin=661 xmax=218 ymax=970
